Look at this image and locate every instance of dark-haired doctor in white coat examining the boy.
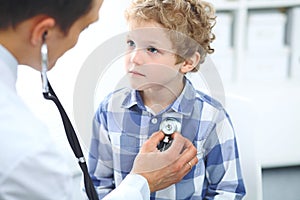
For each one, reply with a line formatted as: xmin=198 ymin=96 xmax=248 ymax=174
xmin=0 ymin=0 xmax=198 ymax=200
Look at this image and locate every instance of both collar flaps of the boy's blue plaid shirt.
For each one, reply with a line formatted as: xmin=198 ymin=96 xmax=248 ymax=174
xmin=122 ymin=78 xmax=196 ymax=115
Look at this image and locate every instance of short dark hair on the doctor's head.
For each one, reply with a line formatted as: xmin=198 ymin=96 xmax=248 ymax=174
xmin=0 ymin=0 xmax=93 ymax=33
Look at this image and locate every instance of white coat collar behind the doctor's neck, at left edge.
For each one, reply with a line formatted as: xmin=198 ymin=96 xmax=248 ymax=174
xmin=0 ymin=44 xmax=18 ymax=89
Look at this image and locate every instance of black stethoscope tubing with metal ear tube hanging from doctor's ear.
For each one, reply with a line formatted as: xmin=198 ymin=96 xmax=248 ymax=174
xmin=41 ymin=33 xmax=99 ymax=200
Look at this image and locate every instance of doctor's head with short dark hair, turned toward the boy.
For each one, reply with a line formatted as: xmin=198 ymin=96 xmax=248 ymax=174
xmin=0 ymin=0 xmax=103 ymax=70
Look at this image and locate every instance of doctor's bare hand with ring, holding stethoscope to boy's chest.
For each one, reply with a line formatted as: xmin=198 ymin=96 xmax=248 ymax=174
xmin=131 ymin=132 xmax=198 ymax=192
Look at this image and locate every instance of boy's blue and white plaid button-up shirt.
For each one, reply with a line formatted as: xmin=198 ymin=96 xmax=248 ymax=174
xmin=89 ymin=79 xmax=245 ymax=200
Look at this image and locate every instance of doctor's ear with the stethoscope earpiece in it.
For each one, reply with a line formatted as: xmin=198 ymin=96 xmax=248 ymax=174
xmin=30 ymin=17 xmax=55 ymax=46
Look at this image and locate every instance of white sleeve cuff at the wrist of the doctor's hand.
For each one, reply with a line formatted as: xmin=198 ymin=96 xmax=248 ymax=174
xmin=103 ymin=174 xmax=150 ymax=200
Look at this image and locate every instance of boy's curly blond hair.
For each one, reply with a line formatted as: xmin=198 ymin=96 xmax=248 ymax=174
xmin=125 ymin=0 xmax=216 ymax=71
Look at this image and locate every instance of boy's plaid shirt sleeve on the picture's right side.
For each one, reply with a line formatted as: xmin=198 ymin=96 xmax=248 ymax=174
xmin=204 ymin=110 xmax=245 ymax=200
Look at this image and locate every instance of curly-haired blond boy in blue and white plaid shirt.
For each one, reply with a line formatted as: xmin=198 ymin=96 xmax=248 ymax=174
xmin=89 ymin=0 xmax=245 ymax=200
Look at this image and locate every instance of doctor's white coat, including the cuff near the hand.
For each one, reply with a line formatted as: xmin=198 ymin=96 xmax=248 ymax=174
xmin=0 ymin=45 xmax=150 ymax=200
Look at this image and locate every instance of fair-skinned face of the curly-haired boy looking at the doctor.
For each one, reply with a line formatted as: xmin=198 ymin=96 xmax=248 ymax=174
xmin=125 ymin=20 xmax=183 ymax=90
